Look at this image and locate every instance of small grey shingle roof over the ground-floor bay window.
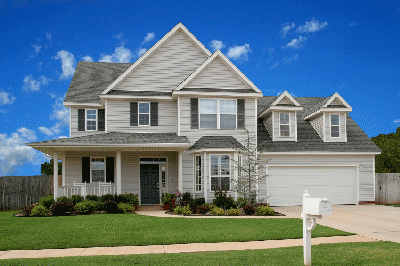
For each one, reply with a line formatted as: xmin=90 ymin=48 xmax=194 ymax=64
xmin=189 ymin=136 xmax=244 ymax=150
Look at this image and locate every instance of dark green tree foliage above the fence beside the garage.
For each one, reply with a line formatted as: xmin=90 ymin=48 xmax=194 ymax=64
xmin=371 ymin=127 xmax=400 ymax=173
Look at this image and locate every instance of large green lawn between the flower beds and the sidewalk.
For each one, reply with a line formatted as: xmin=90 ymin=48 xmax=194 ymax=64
xmin=0 ymin=211 xmax=352 ymax=250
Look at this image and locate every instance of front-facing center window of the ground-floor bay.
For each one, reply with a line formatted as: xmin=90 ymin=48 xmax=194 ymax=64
xmin=210 ymin=155 xmax=231 ymax=190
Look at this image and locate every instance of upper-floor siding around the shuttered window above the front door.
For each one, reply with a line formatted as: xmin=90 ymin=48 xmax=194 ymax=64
xmin=106 ymin=99 xmax=178 ymax=133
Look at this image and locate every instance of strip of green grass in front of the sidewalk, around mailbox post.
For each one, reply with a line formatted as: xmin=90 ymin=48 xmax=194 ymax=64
xmin=1 ymin=242 xmax=400 ymax=266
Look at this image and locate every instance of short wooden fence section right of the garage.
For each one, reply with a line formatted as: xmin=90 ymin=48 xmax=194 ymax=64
xmin=375 ymin=173 xmax=400 ymax=204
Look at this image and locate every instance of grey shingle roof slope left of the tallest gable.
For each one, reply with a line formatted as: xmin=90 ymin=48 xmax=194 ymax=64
xmin=64 ymin=61 xmax=132 ymax=104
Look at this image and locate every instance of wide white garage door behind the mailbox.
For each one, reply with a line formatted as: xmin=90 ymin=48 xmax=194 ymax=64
xmin=267 ymin=166 xmax=357 ymax=206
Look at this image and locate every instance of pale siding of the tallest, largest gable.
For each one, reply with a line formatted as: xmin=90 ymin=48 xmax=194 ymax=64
xmin=112 ymin=30 xmax=208 ymax=91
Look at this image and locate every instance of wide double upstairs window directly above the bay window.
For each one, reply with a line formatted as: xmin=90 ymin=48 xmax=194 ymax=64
xmin=199 ymin=99 xmax=237 ymax=129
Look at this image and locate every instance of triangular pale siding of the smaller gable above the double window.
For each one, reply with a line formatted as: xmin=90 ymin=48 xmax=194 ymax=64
xmin=185 ymin=58 xmax=249 ymax=89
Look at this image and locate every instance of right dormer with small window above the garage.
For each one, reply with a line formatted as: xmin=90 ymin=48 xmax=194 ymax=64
xmin=303 ymin=92 xmax=352 ymax=142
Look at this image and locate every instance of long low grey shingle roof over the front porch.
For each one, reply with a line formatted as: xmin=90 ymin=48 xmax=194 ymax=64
xmin=27 ymin=132 xmax=190 ymax=146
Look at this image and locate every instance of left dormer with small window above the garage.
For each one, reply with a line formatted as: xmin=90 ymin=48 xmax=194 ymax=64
xmin=258 ymin=91 xmax=303 ymax=141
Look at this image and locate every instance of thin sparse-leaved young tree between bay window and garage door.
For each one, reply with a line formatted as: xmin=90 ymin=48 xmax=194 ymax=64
xmin=232 ymin=129 xmax=268 ymax=204
